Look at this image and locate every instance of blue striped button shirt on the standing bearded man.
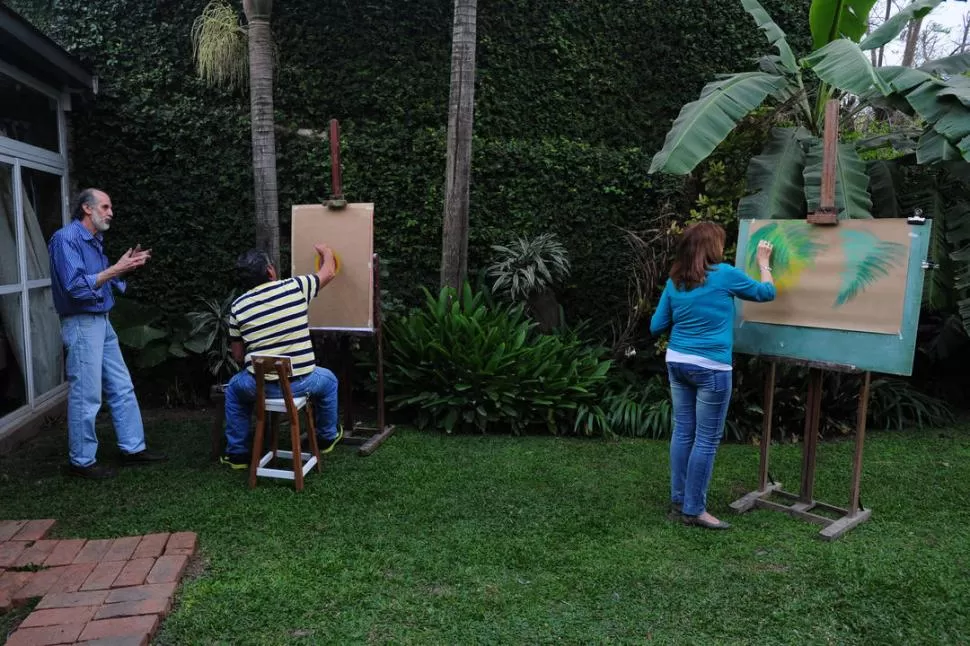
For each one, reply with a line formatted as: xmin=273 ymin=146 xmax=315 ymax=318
xmin=47 ymin=220 xmax=127 ymax=316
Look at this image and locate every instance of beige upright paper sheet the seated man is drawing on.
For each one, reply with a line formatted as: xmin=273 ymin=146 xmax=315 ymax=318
xmin=292 ymin=204 xmax=374 ymax=330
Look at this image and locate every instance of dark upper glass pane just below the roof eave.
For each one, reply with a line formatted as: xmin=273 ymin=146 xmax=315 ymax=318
xmin=0 ymin=73 xmax=60 ymax=152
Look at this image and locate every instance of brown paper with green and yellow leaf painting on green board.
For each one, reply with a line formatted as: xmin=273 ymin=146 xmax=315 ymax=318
xmin=741 ymin=218 xmax=910 ymax=334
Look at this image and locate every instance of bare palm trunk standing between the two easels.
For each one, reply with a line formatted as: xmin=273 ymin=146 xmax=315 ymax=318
xmin=441 ymin=0 xmax=478 ymax=289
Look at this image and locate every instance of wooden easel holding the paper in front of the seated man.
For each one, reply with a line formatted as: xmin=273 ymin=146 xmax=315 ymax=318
xmin=310 ymin=119 xmax=394 ymax=456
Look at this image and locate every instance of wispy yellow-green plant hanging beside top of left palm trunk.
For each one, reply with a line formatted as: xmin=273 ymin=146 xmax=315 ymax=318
xmin=192 ymin=0 xmax=249 ymax=89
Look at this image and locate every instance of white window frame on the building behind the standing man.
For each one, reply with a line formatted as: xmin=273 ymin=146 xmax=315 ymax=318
xmin=0 ymin=61 xmax=71 ymax=436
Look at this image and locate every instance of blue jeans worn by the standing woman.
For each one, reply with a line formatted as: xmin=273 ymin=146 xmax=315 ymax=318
xmin=667 ymin=363 xmax=732 ymax=516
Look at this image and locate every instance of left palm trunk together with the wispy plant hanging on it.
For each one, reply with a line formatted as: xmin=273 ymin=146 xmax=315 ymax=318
xmin=192 ymin=0 xmax=280 ymax=267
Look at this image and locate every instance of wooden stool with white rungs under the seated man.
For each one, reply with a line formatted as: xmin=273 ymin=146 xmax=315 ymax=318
xmin=249 ymin=355 xmax=322 ymax=491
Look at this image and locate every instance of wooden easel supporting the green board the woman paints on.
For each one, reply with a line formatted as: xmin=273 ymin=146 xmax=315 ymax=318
xmin=731 ymin=100 xmax=872 ymax=540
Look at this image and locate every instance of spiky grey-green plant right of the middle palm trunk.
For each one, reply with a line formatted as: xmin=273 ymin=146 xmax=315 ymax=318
xmin=486 ymin=233 xmax=570 ymax=303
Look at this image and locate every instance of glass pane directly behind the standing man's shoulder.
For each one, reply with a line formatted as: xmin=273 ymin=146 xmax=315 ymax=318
xmin=20 ymin=166 xmax=64 ymax=280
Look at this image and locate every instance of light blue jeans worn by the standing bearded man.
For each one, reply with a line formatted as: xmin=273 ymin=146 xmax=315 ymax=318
xmin=61 ymin=314 xmax=145 ymax=467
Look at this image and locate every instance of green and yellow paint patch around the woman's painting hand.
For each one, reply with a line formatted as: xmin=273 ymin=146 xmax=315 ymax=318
xmin=745 ymin=220 xmax=828 ymax=291
